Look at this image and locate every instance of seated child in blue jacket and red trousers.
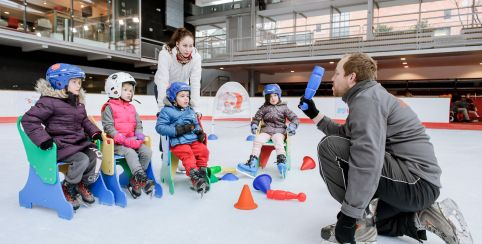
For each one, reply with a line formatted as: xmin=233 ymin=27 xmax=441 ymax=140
xmin=156 ymin=82 xmax=209 ymax=193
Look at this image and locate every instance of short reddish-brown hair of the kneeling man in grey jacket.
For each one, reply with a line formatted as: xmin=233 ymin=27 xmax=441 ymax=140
xmin=343 ymin=53 xmax=377 ymax=82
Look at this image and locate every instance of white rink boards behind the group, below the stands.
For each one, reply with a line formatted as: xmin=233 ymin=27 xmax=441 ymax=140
xmin=0 ymin=91 xmax=450 ymax=123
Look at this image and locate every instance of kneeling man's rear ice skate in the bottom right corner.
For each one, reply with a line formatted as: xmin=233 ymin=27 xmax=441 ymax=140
xmin=415 ymin=198 xmax=473 ymax=244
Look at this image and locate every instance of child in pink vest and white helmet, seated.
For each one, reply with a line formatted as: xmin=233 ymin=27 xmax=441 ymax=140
xmin=101 ymin=72 xmax=155 ymax=199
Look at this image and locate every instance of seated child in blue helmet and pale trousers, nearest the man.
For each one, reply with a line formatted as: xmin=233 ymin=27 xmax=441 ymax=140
xmin=237 ymin=84 xmax=299 ymax=177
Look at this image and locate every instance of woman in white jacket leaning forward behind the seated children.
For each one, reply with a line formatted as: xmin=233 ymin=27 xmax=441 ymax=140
xmin=154 ymin=28 xmax=201 ymax=112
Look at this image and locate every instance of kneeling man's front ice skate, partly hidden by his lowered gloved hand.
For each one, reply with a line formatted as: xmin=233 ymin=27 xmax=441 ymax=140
xmin=321 ymin=199 xmax=378 ymax=244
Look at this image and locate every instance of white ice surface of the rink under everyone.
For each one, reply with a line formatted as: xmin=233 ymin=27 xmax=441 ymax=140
xmin=0 ymin=121 xmax=482 ymax=244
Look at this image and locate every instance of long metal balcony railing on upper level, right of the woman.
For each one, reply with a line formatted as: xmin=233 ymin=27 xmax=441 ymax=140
xmin=196 ymin=6 xmax=482 ymax=63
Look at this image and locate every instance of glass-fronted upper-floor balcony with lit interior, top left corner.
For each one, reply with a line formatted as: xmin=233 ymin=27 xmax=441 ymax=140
xmin=0 ymin=0 xmax=140 ymax=55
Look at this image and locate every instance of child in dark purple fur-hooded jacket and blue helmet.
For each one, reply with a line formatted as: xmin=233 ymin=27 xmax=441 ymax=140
xmin=22 ymin=63 xmax=102 ymax=210
